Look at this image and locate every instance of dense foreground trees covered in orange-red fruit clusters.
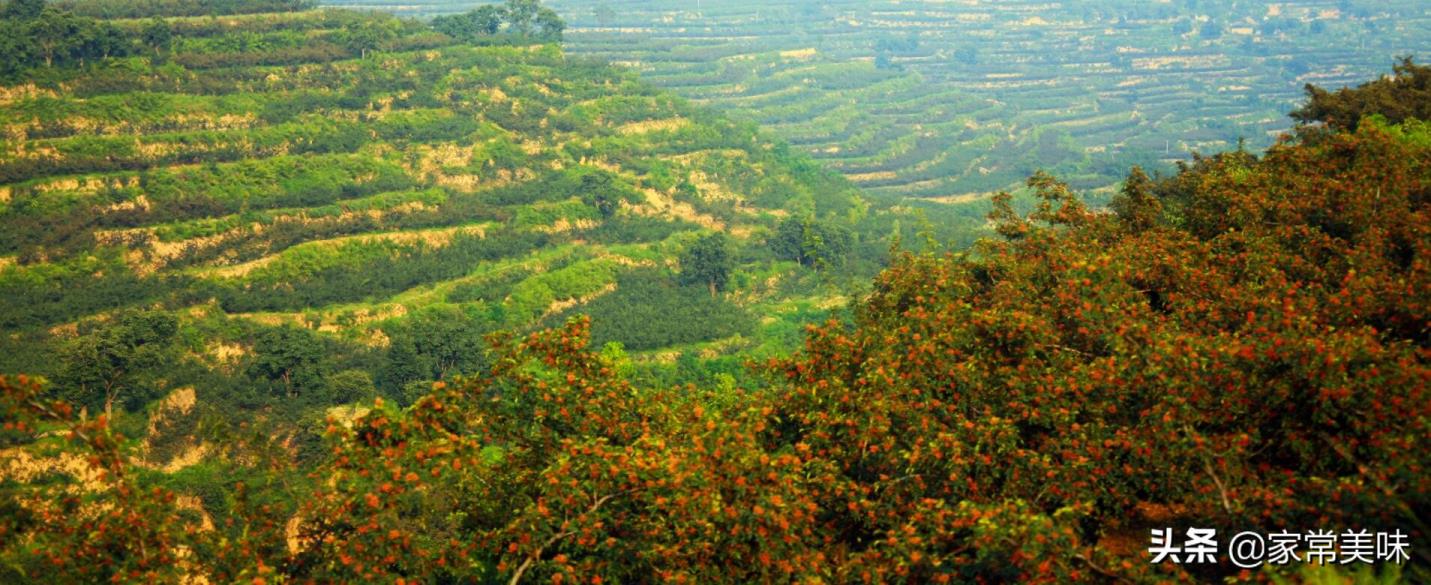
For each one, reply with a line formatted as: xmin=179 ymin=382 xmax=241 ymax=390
xmin=0 ymin=53 xmax=1431 ymax=584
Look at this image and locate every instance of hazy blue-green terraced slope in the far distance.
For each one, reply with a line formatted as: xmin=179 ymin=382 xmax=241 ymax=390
xmin=329 ymin=0 xmax=1431 ymax=202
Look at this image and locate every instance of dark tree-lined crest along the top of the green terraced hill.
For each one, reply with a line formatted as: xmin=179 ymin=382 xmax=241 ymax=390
xmin=0 ymin=0 xmax=567 ymax=83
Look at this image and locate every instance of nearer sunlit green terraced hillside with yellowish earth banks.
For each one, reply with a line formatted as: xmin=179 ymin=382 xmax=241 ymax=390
xmin=0 ymin=4 xmax=889 ymax=423
